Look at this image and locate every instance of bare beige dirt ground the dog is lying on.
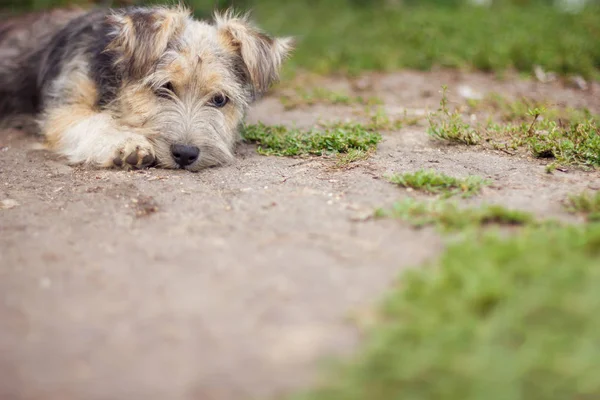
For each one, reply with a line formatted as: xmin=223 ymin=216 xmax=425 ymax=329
xmin=0 ymin=72 xmax=600 ymax=400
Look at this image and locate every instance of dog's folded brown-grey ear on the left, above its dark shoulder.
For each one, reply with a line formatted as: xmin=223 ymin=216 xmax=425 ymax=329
xmin=106 ymin=7 xmax=190 ymax=79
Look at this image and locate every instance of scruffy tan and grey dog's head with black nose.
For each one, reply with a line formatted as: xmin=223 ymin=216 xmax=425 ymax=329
xmin=106 ymin=8 xmax=291 ymax=171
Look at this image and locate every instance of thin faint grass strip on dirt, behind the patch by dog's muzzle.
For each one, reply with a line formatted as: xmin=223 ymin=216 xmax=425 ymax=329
xmin=280 ymin=87 xmax=382 ymax=110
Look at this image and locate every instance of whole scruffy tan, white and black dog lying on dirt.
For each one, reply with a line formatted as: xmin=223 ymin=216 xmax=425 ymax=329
xmin=0 ymin=7 xmax=291 ymax=171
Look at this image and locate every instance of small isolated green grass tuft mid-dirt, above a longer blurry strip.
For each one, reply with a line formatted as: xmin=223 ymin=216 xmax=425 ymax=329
xmin=387 ymin=170 xmax=490 ymax=197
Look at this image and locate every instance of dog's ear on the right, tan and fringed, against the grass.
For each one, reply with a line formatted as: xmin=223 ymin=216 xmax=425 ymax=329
xmin=214 ymin=10 xmax=293 ymax=94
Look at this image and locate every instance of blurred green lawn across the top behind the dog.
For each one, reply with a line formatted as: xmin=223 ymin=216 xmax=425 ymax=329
xmin=0 ymin=0 xmax=600 ymax=79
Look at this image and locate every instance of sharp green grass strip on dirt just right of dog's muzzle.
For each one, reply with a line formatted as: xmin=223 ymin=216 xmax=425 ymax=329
xmin=242 ymin=124 xmax=381 ymax=157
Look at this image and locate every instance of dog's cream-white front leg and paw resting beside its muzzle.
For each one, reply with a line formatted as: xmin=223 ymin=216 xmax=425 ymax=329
xmin=42 ymin=104 xmax=155 ymax=168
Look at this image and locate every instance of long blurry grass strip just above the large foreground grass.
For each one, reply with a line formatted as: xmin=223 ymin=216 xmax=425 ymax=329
xmin=375 ymin=198 xmax=535 ymax=231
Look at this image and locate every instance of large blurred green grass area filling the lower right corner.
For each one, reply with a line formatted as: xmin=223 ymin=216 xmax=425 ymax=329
xmin=294 ymin=224 xmax=600 ymax=400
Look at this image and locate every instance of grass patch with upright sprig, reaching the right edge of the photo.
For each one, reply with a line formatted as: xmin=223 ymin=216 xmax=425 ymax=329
xmin=429 ymin=87 xmax=600 ymax=171
